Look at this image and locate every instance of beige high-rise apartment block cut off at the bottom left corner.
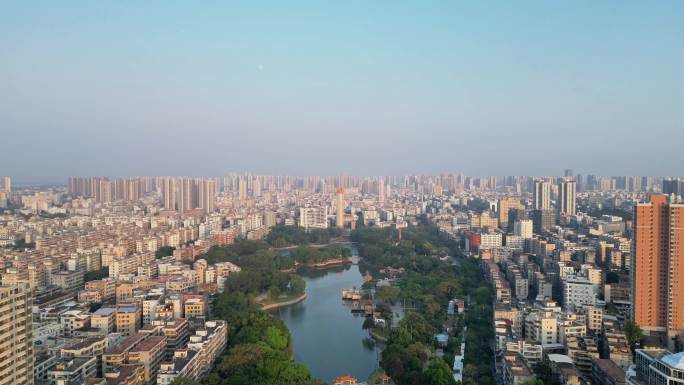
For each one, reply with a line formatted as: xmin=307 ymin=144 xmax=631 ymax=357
xmin=0 ymin=284 xmax=33 ymax=385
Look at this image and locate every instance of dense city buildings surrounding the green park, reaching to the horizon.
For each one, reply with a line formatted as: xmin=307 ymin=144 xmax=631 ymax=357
xmin=0 ymin=174 xmax=682 ymax=385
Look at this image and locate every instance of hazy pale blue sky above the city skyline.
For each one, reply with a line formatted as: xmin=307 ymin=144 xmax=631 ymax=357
xmin=0 ymin=0 xmax=684 ymax=181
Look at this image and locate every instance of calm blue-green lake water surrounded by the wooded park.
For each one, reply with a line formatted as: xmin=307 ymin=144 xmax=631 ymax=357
xmin=274 ymin=250 xmax=380 ymax=383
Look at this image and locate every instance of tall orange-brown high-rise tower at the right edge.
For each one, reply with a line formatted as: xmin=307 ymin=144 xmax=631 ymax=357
xmin=632 ymin=194 xmax=684 ymax=344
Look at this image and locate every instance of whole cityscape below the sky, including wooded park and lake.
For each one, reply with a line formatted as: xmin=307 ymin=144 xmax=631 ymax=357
xmin=0 ymin=169 xmax=684 ymax=385
